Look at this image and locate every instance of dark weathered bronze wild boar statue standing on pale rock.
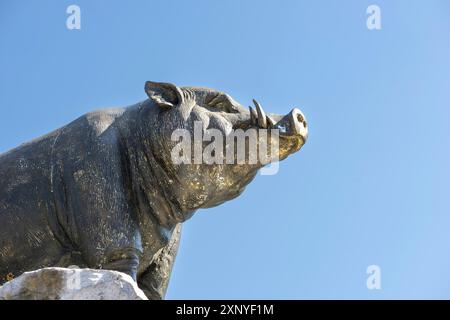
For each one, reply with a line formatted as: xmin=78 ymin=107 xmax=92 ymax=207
xmin=0 ymin=82 xmax=307 ymax=299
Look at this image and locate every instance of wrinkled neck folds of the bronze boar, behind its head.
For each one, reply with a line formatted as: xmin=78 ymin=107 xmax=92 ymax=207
xmin=119 ymin=102 xmax=193 ymax=229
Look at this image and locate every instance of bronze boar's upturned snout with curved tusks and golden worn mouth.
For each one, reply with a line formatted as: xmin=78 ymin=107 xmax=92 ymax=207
xmin=232 ymin=100 xmax=308 ymax=160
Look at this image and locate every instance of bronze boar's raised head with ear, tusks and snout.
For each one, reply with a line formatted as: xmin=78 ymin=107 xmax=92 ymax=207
xmin=143 ymin=81 xmax=308 ymax=219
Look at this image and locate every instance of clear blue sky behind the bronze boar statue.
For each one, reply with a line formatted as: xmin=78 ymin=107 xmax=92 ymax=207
xmin=0 ymin=0 xmax=450 ymax=299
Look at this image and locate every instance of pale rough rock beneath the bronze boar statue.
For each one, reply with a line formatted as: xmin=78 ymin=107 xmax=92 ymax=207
xmin=0 ymin=268 xmax=148 ymax=300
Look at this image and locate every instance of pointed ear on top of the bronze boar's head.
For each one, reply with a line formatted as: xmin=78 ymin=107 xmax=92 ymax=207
xmin=145 ymin=81 xmax=183 ymax=109
